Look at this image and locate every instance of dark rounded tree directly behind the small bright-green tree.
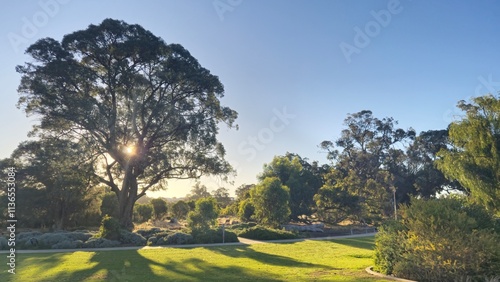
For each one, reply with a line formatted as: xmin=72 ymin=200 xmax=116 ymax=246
xmin=259 ymin=153 xmax=322 ymax=219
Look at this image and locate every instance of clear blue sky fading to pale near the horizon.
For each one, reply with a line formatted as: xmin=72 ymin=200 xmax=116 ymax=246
xmin=0 ymin=0 xmax=500 ymax=197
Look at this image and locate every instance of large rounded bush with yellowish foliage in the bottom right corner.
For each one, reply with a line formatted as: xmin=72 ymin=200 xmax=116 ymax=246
xmin=375 ymin=198 xmax=500 ymax=281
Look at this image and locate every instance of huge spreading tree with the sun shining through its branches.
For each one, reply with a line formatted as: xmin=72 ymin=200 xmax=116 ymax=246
xmin=17 ymin=19 xmax=237 ymax=229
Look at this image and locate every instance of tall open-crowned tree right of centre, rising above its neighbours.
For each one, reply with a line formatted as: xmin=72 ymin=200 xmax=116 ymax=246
xmin=318 ymin=110 xmax=415 ymax=223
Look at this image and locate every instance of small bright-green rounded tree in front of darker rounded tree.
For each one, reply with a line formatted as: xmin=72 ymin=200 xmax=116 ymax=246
xmin=250 ymin=177 xmax=290 ymax=227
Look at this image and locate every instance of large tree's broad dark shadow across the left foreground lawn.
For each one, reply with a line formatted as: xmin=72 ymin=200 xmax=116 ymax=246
xmin=15 ymin=249 xmax=281 ymax=282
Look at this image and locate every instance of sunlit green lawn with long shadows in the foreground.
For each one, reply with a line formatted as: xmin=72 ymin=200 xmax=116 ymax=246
xmin=0 ymin=237 xmax=390 ymax=282
